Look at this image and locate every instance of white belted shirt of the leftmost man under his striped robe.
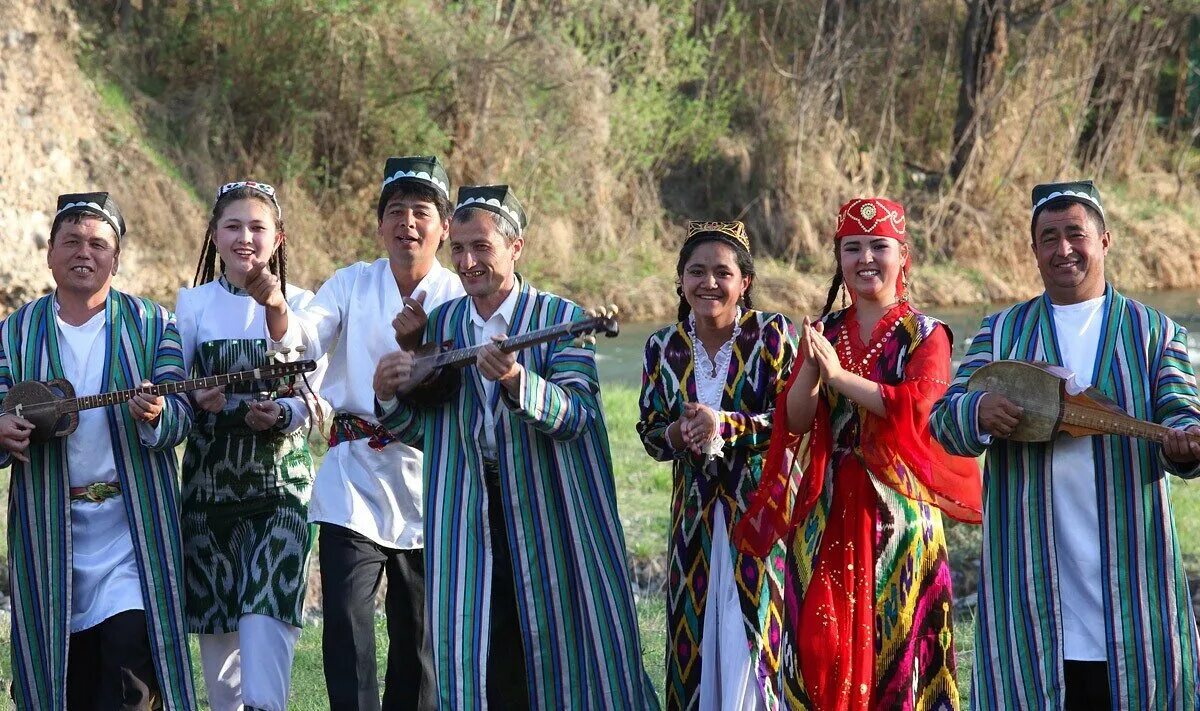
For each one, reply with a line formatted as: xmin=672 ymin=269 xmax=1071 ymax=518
xmin=54 ymin=300 xmax=144 ymax=633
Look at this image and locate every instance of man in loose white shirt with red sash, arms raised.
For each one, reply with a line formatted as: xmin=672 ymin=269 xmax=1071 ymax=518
xmin=246 ymin=156 xmax=463 ymax=711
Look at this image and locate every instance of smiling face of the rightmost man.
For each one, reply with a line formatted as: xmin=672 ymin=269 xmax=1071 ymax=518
xmin=1033 ymin=203 xmax=1111 ymax=304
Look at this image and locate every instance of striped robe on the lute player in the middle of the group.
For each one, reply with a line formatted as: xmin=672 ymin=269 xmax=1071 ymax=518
xmin=380 ymin=280 xmax=658 ymax=711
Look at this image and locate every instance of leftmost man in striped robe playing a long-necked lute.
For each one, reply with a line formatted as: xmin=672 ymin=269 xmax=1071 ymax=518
xmin=0 ymin=192 xmax=196 ymax=711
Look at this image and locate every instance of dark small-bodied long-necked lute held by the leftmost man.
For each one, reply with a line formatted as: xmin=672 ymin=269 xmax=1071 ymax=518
xmin=0 ymin=360 xmax=317 ymax=443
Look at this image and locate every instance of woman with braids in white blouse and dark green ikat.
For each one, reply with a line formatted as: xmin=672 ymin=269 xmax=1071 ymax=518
xmin=175 ymin=181 xmax=321 ymax=711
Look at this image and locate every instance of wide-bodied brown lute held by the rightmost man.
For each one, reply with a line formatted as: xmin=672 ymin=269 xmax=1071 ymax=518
xmin=967 ymin=360 xmax=1200 ymax=443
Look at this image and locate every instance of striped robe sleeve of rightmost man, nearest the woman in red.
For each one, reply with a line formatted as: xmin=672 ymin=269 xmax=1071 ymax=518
xmin=929 ymin=316 xmax=996 ymax=456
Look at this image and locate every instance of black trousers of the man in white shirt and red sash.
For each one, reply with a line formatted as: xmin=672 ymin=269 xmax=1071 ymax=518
xmin=318 ymin=524 xmax=437 ymax=711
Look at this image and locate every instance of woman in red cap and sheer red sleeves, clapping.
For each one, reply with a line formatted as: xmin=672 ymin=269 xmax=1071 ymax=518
xmin=734 ymin=198 xmax=980 ymax=711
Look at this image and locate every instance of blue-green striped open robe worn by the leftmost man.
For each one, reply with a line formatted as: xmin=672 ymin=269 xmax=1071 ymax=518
xmin=0 ymin=289 xmax=197 ymax=711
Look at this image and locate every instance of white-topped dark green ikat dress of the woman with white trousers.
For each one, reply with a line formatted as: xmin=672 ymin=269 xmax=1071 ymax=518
xmin=178 ymin=277 xmax=314 ymax=634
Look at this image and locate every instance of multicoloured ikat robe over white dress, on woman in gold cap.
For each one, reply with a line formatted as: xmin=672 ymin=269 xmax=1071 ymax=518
xmin=637 ymin=310 xmax=797 ymax=709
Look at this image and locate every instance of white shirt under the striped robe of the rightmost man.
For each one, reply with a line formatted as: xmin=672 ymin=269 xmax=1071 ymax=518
xmin=1050 ymin=297 xmax=1108 ymax=662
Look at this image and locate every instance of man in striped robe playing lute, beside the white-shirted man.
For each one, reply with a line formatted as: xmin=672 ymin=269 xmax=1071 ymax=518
xmin=374 ymin=185 xmax=658 ymax=711
